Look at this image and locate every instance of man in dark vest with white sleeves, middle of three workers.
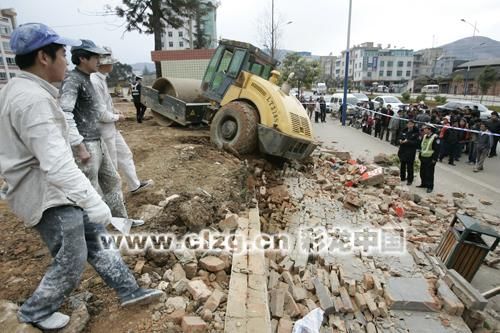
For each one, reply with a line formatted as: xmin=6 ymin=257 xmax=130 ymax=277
xmin=60 ymin=39 xmax=144 ymax=226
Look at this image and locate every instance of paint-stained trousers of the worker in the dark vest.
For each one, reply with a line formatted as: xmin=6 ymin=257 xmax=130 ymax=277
xmin=76 ymin=140 xmax=128 ymax=218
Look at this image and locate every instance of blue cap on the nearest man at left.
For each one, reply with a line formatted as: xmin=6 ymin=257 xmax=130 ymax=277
xmin=10 ymin=23 xmax=82 ymax=55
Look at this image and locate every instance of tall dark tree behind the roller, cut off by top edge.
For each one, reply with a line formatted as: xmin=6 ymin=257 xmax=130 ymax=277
xmin=114 ymin=0 xmax=200 ymax=77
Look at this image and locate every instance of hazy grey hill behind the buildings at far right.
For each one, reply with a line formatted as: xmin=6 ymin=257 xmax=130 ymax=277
xmin=441 ymin=36 xmax=500 ymax=60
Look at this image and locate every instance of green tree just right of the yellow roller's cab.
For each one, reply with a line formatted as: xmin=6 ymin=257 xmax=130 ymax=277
xmin=281 ymin=53 xmax=320 ymax=89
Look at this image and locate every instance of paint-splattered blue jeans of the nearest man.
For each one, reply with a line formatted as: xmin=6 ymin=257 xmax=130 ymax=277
xmin=18 ymin=206 xmax=138 ymax=323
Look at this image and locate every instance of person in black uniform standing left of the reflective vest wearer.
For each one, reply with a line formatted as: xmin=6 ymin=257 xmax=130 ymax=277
xmin=398 ymin=119 xmax=419 ymax=185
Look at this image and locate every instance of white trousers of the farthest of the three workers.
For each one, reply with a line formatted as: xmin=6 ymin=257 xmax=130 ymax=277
xmin=103 ymin=131 xmax=141 ymax=191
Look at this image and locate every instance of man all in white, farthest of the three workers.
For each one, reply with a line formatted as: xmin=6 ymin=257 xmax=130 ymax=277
xmin=90 ymin=47 xmax=154 ymax=194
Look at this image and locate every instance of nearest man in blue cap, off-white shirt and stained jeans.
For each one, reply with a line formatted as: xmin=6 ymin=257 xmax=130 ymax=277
xmin=0 ymin=23 xmax=163 ymax=331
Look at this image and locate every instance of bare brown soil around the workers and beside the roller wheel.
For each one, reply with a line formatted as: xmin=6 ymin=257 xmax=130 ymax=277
xmin=0 ymin=101 xmax=248 ymax=333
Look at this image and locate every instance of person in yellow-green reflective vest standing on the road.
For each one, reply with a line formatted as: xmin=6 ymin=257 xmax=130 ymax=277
xmin=417 ymin=124 xmax=439 ymax=193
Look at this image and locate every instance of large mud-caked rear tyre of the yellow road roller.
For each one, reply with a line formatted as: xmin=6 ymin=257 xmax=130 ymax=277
xmin=210 ymin=102 xmax=259 ymax=154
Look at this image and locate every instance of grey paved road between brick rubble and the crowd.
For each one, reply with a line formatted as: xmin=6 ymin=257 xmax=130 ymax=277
xmin=313 ymin=116 xmax=500 ymax=215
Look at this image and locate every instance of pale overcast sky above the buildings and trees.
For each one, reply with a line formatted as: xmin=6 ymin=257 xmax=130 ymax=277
xmin=0 ymin=0 xmax=500 ymax=63
